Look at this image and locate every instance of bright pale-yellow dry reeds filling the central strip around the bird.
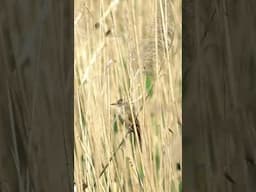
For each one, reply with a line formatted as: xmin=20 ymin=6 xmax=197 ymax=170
xmin=74 ymin=0 xmax=181 ymax=192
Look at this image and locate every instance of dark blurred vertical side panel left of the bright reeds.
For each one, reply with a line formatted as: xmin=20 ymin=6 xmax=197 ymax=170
xmin=0 ymin=0 xmax=74 ymax=192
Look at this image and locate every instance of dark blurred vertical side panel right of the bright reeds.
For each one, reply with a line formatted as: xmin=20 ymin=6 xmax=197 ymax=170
xmin=182 ymin=0 xmax=256 ymax=192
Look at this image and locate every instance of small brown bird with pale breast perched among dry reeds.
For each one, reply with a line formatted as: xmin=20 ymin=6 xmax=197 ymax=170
xmin=111 ymin=99 xmax=142 ymax=147
